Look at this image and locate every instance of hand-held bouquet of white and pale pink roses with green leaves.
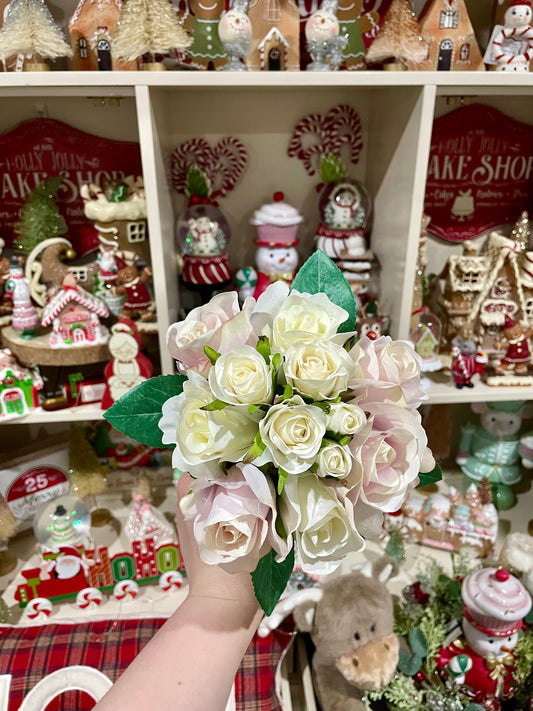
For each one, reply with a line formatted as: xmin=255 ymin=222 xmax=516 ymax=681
xmin=106 ymin=251 xmax=438 ymax=614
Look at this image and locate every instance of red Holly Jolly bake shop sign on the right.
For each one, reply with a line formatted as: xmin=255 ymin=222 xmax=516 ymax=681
xmin=425 ymin=104 xmax=533 ymax=242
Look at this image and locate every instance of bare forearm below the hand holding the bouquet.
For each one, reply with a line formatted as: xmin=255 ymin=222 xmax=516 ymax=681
xmin=95 ymin=596 xmax=261 ymax=711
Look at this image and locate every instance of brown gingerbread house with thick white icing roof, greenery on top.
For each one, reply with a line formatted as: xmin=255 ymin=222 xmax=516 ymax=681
xmin=80 ymin=176 xmax=150 ymax=264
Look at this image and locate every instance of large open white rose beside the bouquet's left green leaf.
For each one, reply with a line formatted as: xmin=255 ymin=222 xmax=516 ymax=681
xmin=159 ymin=371 xmax=262 ymax=478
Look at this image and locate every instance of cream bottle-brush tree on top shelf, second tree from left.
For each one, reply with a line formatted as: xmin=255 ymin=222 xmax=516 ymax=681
xmin=112 ymin=0 xmax=191 ymax=70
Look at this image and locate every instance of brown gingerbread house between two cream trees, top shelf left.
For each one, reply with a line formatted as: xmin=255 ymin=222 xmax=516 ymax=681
xmin=69 ymin=0 xmax=138 ymax=71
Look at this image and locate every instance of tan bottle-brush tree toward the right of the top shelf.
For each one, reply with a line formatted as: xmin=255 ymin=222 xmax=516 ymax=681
xmin=366 ymin=0 xmax=428 ymax=70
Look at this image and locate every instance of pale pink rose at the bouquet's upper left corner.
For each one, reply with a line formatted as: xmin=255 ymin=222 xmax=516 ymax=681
xmin=167 ymin=291 xmax=257 ymax=375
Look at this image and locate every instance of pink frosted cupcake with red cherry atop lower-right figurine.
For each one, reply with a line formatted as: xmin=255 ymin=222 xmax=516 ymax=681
xmin=461 ymin=568 xmax=531 ymax=637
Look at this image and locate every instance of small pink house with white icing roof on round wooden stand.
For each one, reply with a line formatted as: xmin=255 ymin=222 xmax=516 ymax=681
xmin=42 ymin=274 xmax=109 ymax=348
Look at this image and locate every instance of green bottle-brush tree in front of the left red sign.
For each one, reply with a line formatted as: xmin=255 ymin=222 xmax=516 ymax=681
xmin=15 ymin=175 xmax=63 ymax=255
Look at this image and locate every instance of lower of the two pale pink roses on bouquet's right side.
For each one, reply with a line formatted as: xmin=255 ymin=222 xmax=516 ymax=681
xmin=348 ymin=403 xmax=427 ymax=512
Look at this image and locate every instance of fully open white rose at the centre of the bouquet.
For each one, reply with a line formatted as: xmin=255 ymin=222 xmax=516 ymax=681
xmin=255 ymin=395 xmax=326 ymax=474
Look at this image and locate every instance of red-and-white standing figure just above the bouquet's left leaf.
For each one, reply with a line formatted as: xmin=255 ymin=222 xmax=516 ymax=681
xmin=102 ymin=318 xmax=154 ymax=410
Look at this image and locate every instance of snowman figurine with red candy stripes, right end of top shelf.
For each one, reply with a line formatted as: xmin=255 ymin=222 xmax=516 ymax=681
xmin=491 ymin=0 xmax=533 ymax=72
